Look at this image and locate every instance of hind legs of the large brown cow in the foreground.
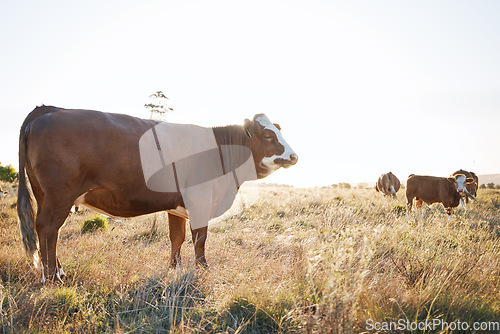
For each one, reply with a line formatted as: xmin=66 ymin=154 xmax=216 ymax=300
xmin=36 ymin=198 xmax=71 ymax=281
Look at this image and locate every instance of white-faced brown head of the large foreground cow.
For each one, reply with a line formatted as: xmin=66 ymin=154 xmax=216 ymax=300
xmin=244 ymin=114 xmax=298 ymax=179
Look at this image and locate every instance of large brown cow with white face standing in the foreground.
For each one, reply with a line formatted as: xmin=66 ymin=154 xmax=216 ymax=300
xmin=17 ymin=106 xmax=298 ymax=282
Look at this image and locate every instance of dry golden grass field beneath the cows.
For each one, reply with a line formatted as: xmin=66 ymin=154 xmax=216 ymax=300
xmin=0 ymin=183 xmax=500 ymax=333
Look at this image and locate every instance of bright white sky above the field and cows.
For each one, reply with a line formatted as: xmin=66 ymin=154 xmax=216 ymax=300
xmin=0 ymin=0 xmax=500 ymax=186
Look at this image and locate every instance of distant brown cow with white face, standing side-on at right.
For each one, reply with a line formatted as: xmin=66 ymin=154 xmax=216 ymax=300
xmin=406 ymin=174 xmax=475 ymax=218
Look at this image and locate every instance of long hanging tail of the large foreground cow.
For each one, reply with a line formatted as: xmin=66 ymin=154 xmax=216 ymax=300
xmin=17 ymin=106 xmax=54 ymax=267
